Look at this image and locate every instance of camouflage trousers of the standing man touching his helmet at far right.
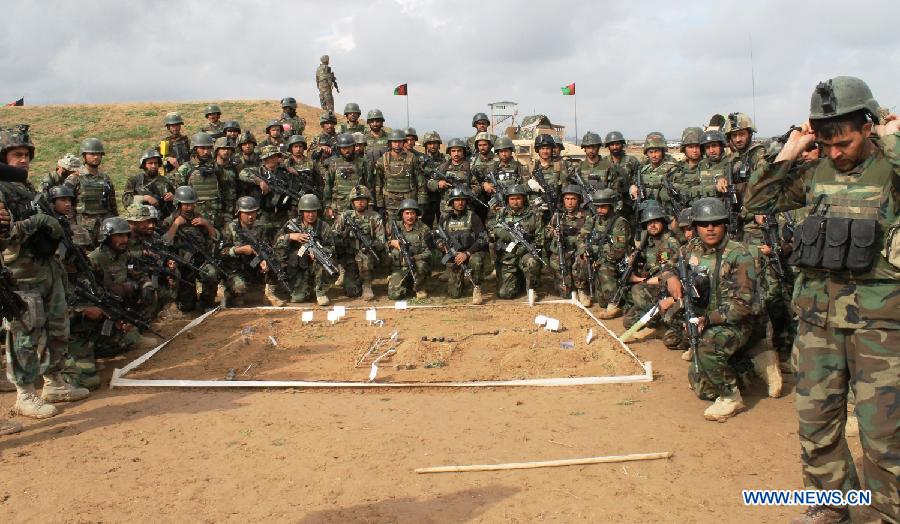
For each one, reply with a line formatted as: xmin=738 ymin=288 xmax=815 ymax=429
xmin=792 ymin=321 xmax=900 ymax=522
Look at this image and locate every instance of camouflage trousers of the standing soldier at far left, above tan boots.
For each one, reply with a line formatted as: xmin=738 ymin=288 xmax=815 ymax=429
xmin=6 ymin=258 xmax=69 ymax=389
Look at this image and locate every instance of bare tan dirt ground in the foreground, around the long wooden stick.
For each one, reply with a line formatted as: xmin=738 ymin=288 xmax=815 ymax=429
xmin=0 ymin=290 xmax=876 ymax=523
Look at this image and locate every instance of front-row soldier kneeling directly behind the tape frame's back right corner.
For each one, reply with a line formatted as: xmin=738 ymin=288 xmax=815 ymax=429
xmin=544 ymin=184 xmax=593 ymax=307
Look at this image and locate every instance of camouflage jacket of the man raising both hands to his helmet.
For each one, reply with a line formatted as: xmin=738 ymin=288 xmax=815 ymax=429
xmin=746 ymin=133 xmax=900 ymax=329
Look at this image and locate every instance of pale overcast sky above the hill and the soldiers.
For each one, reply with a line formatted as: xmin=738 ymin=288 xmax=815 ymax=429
xmin=0 ymin=0 xmax=900 ymax=140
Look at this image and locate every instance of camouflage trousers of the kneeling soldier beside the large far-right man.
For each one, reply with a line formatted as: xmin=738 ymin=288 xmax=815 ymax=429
xmin=688 ymin=325 xmax=752 ymax=400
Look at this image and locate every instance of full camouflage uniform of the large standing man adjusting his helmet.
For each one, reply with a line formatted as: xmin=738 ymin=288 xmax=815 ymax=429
xmin=746 ymin=133 xmax=900 ymax=521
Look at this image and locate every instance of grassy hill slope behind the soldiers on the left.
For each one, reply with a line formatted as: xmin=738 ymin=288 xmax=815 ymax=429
xmin=0 ymin=100 xmax=330 ymax=187
